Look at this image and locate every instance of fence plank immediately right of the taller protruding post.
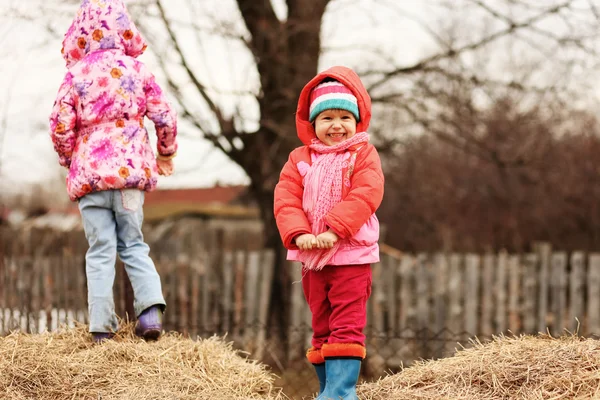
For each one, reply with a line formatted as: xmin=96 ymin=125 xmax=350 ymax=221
xmin=550 ymin=251 xmax=567 ymax=336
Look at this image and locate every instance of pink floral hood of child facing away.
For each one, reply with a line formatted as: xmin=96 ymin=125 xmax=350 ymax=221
xmin=62 ymin=0 xmax=146 ymax=68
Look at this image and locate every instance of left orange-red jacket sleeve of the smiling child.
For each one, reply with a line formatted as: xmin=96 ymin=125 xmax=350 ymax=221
xmin=274 ymin=152 xmax=311 ymax=250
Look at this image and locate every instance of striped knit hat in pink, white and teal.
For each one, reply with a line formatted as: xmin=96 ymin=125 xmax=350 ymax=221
xmin=308 ymin=80 xmax=360 ymax=122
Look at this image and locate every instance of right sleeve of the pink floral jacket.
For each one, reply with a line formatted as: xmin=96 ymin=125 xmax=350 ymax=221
xmin=144 ymin=67 xmax=177 ymax=157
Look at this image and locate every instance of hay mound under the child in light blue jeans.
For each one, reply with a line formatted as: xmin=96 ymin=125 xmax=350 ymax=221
xmin=0 ymin=324 xmax=285 ymax=400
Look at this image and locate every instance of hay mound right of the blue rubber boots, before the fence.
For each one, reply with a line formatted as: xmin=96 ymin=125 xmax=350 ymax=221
xmin=358 ymin=335 xmax=600 ymax=400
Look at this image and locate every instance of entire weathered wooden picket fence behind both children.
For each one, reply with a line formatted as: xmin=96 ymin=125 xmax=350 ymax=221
xmin=0 ymin=225 xmax=600 ymax=368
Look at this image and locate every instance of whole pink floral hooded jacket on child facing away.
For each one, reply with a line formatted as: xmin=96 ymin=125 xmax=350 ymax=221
xmin=50 ymin=0 xmax=177 ymax=200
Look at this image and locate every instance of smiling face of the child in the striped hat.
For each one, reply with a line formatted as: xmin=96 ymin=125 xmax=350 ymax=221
xmin=315 ymin=109 xmax=356 ymax=146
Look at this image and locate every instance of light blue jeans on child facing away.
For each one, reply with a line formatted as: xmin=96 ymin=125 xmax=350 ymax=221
xmin=79 ymin=189 xmax=166 ymax=332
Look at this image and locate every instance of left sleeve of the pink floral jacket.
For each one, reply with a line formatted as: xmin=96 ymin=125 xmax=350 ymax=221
xmin=50 ymin=72 xmax=77 ymax=168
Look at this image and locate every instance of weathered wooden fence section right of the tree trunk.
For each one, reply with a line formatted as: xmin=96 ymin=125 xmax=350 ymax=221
xmin=290 ymin=244 xmax=600 ymax=369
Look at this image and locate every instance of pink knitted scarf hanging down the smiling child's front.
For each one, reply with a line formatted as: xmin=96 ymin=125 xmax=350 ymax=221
xmin=298 ymin=132 xmax=369 ymax=271
